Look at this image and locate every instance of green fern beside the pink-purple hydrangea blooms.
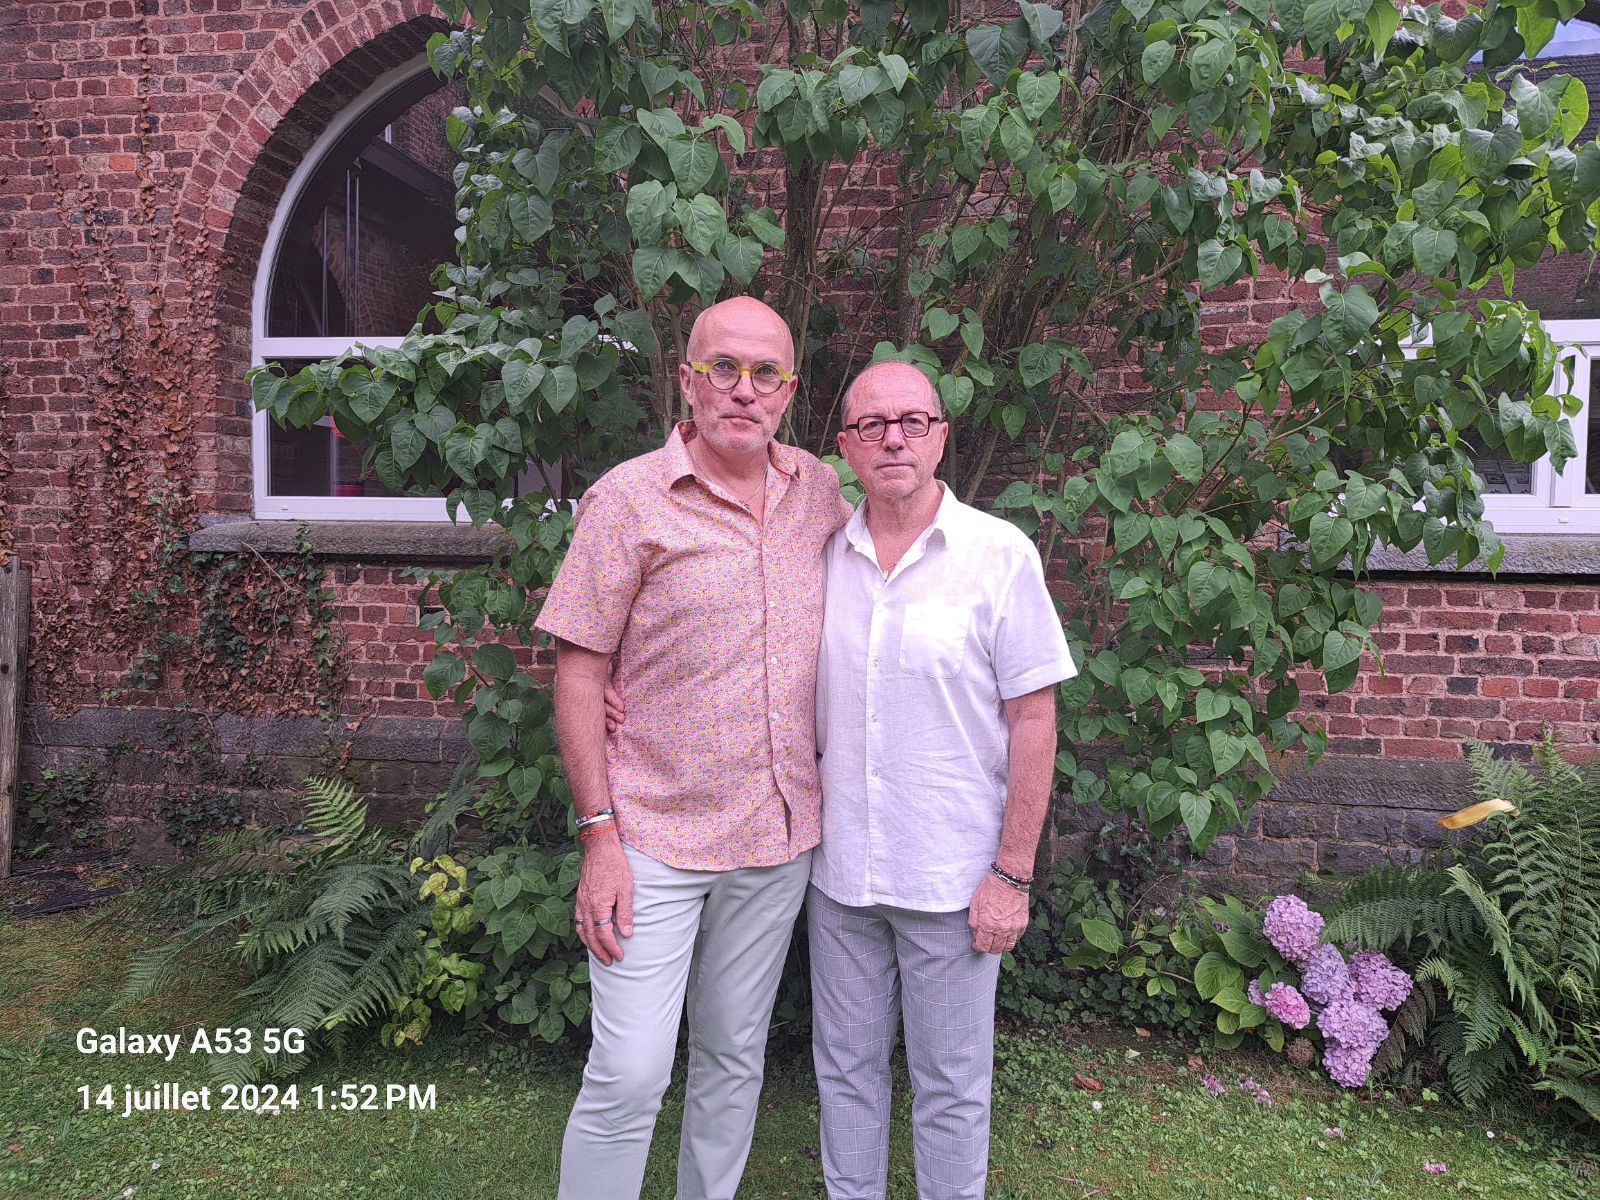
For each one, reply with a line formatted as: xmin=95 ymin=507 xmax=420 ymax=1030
xmin=1328 ymin=736 xmax=1600 ymax=1122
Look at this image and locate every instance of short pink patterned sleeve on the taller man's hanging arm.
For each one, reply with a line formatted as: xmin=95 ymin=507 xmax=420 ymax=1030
xmin=534 ymin=480 xmax=646 ymax=654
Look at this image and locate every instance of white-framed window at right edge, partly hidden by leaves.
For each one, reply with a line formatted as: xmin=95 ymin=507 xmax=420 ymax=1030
xmin=1475 ymin=318 xmax=1600 ymax=534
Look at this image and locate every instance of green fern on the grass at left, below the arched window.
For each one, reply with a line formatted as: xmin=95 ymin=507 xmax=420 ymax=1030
xmin=109 ymin=779 xmax=427 ymax=1082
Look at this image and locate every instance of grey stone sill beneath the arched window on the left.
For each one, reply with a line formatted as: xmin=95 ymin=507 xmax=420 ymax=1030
xmin=189 ymin=514 xmax=506 ymax=563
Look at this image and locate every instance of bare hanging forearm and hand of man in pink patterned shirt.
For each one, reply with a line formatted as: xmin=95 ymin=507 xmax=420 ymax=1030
xmin=555 ymin=638 xmax=634 ymax=966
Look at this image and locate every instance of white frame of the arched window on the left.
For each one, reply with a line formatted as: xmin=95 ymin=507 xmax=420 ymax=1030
xmin=250 ymin=54 xmax=450 ymax=522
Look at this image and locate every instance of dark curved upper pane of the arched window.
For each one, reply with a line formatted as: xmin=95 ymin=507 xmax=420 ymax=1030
xmin=267 ymin=74 xmax=461 ymax=338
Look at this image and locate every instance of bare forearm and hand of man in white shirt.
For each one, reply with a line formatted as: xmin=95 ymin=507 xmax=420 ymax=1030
xmin=968 ymin=683 xmax=1056 ymax=954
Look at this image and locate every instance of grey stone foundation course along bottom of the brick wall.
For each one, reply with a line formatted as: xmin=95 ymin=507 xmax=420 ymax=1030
xmin=22 ymin=706 xmax=1475 ymax=893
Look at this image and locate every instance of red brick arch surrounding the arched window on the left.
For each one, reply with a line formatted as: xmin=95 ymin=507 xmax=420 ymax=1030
xmin=189 ymin=0 xmax=450 ymax=514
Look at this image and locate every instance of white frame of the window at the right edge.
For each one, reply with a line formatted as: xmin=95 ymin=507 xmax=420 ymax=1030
xmin=1483 ymin=318 xmax=1600 ymax=534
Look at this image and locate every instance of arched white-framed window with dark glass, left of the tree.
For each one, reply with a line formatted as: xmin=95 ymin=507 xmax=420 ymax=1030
xmin=251 ymin=56 xmax=459 ymax=522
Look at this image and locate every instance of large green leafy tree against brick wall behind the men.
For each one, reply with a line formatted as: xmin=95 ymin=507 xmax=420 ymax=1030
xmin=254 ymin=0 xmax=1600 ymax=1036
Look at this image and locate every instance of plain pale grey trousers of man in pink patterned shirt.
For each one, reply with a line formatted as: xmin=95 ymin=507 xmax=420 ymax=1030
xmin=557 ymin=846 xmax=811 ymax=1200
